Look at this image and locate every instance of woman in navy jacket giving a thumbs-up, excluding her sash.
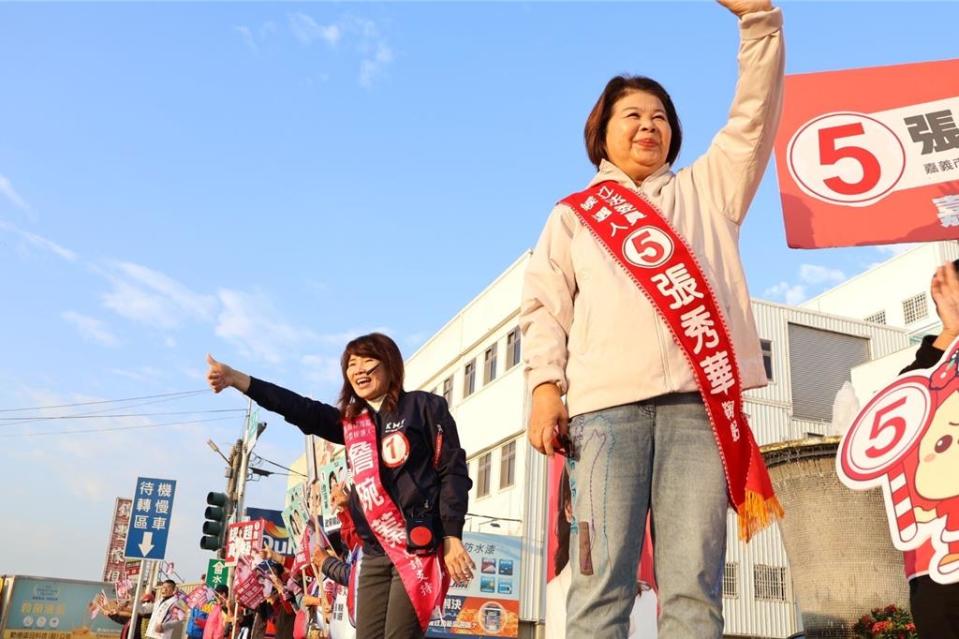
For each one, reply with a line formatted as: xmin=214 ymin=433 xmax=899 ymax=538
xmin=207 ymin=333 xmax=475 ymax=639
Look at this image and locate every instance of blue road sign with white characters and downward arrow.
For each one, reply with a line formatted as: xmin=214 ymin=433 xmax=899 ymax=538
xmin=124 ymin=477 xmax=176 ymax=559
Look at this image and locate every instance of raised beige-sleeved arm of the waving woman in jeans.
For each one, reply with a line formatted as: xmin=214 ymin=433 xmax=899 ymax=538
xmin=690 ymin=0 xmax=785 ymax=224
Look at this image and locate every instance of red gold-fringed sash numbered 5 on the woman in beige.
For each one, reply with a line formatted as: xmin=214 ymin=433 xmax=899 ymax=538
xmin=563 ymin=181 xmax=783 ymax=541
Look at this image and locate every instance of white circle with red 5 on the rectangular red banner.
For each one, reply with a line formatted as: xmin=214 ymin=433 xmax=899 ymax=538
xmin=786 ymin=113 xmax=906 ymax=206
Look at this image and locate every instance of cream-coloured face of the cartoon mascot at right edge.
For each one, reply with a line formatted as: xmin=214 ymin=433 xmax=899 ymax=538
xmin=916 ymin=392 xmax=959 ymax=500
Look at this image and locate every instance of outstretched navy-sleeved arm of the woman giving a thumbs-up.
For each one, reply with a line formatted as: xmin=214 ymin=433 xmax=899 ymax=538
xmin=206 ymin=355 xmax=343 ymax=444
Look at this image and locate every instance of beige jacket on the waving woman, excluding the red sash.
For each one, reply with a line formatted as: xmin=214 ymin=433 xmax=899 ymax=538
xmin=520 ymin=9 xmax=784 ymax=424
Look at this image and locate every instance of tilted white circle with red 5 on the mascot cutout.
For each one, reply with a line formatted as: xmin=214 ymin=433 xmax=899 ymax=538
xmin=841 ymin=378 xmax=932 ymax=481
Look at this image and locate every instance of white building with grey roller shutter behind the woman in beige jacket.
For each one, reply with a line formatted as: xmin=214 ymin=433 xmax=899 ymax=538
xmin=407 ymin=253 xmax=912 ymax=638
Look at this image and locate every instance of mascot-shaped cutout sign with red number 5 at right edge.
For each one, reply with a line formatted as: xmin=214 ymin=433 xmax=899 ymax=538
xmin=836 ymin=339 xmax=959 ymax=583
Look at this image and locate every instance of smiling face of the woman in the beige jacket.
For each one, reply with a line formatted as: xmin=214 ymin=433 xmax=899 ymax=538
xmin=606 ymin=91 xmax=672 ymax=183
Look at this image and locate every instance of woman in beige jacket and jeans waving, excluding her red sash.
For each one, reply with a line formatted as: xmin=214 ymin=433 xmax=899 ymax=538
xmin=520 ymin=0 xmax=784 ymax=639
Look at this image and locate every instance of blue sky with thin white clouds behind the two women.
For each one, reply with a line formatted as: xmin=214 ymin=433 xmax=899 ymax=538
xmin=0 ymin=2 xmax=959 ymax=578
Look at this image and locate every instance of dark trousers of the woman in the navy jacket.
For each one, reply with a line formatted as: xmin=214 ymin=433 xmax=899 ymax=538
xmin=356 ymin=556 xmax=423 ymax=639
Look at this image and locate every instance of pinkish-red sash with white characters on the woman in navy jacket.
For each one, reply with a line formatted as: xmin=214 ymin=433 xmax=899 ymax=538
xmin=343 ymin=411 xmax=449 ymax=632
